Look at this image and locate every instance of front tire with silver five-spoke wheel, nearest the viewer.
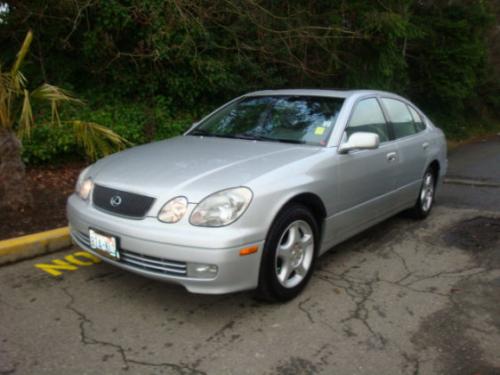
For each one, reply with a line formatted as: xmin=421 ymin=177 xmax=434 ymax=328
xmin=256 ymin=204 xmax=319 ymax=302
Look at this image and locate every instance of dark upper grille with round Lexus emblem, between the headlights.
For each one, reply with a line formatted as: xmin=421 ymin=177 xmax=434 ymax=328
xmin=92 ymin=185 xmax=154 ymax=218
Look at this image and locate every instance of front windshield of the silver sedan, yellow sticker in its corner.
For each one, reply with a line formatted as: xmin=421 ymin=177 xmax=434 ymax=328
xmin=188 ymin=96 xmax=344 ymax=145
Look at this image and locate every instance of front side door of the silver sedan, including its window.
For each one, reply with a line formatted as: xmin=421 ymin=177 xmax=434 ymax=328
xmin=325 ymin=97 xmax=399 ymax=247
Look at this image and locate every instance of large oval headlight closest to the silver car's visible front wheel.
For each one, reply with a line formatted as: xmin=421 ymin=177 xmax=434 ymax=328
xmin=189 ymin=187 xmax=252 ymax=227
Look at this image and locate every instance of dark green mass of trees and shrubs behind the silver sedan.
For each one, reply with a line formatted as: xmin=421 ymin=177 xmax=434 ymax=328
xmin=0 ymin=0 xmax=500 ymax=160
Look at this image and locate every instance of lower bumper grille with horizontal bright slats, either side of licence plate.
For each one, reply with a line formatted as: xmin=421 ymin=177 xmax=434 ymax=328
xmin=71 ymin=231 xmax=187 ymax=276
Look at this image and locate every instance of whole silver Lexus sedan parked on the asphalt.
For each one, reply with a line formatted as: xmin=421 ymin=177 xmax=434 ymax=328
xmin=67 ymin=90 xmax=447 ymax=301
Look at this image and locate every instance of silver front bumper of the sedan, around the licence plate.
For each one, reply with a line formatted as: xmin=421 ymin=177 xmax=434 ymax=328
xmin=67 ymin=195 xmax=270 ymax=294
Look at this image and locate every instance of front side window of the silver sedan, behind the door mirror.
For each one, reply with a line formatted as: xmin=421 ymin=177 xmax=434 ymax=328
xmin=346 ymin=98 xmax=389 ymax=143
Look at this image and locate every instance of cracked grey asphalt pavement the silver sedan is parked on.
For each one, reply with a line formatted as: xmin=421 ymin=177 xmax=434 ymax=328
xmin=0 ymin=137 xmax=500 ymax=375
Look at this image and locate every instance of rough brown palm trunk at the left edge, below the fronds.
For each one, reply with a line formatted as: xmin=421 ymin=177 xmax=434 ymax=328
xmin=0 ymin=128 xmax=33 ymax=211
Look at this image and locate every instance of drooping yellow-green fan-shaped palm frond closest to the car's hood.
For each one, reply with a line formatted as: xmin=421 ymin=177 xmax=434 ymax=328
xmin=69 ymin=120 xmax=132 ymax=160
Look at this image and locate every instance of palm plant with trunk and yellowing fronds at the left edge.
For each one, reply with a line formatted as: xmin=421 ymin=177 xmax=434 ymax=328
xmin=0 ymin=31 xmax=128 ymax=210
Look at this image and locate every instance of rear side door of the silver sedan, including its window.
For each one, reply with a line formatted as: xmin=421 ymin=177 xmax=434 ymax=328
xmin=381 ymin=98 xmax=429 ymax=202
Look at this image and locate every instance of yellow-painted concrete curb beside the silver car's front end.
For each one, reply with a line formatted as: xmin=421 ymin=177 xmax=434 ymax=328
xmin=0 ymin=227 xmax=71 ymax=265
